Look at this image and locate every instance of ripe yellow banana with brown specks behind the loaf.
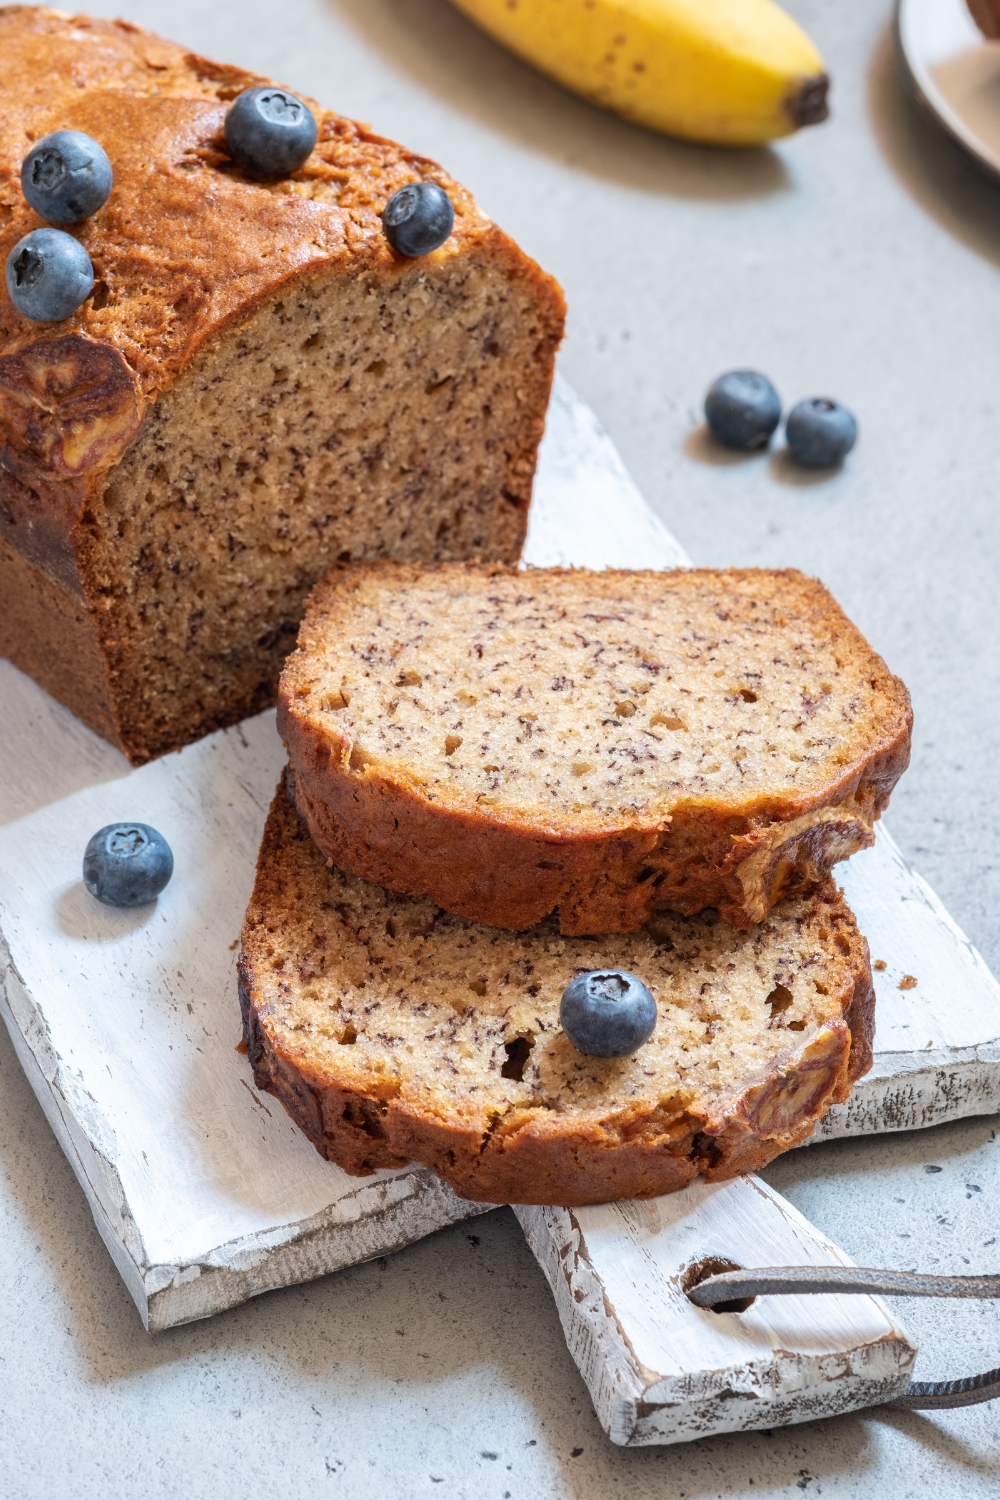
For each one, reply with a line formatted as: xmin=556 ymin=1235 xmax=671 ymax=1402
xmin=454 ymin=0 xmax=829 ymax=146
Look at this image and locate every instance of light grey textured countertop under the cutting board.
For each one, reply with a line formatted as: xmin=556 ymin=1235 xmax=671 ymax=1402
xmin=0 ymin=0 xmax=1000 ymax=1500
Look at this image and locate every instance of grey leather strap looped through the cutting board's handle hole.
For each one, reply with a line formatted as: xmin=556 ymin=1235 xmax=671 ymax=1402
xmin=687 ymin=1266 xmax=1000 ymax=1412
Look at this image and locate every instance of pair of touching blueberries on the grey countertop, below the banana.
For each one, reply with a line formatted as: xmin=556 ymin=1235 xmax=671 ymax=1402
xmin=705 ymin=371 xmax=858 ymax=468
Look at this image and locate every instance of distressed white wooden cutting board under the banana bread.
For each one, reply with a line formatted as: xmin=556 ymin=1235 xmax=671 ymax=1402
xmin=0 ymin=384 xmax=1000 ymax=1443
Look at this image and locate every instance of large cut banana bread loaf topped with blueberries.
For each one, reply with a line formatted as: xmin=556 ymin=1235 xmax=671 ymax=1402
xmin=0 ymin=6 xmax=564 ymax=762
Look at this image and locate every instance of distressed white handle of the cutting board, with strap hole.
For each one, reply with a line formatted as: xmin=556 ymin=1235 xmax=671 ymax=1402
xmin=514 ymin=1178 xmax=916 ymax=1446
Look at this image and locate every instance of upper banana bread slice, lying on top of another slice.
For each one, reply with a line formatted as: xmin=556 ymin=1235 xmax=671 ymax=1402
xmin=279 ymin=566 xmax=912 ymax=935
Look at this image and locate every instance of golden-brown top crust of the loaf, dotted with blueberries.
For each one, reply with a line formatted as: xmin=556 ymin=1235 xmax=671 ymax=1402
xmin=0 ymin=6 xmax=509 ymax=396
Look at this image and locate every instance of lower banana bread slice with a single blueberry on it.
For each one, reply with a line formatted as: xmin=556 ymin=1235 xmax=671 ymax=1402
xmin=240 ymin=788 xmax=874 ymax=1205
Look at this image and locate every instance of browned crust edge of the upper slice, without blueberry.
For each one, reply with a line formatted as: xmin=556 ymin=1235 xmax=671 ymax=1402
xmin=279 ymin=564 xmax=913 ymax=936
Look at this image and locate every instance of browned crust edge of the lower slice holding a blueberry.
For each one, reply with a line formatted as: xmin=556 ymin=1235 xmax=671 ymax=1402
xmin=238 ymin=788 xmax=874 ymax=1205
